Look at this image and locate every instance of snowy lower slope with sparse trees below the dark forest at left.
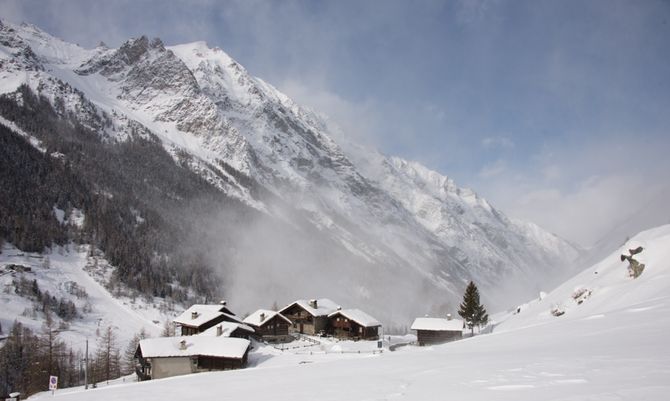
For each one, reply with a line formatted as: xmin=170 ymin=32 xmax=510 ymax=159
xmin=0 ymin=244 xmax=165 ymax=349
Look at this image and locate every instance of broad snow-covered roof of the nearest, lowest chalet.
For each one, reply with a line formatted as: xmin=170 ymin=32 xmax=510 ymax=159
xmin=140 ymin=336 xmax=251 ymax=359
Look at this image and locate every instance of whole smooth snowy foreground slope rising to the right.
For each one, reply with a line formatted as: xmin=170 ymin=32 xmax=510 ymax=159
xmin=32 ymin=226 xmax=670 ymax=401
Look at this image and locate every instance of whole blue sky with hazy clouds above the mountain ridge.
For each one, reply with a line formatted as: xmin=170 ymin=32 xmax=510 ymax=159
xmin=0 ymin=0 xmax=670 ymax=245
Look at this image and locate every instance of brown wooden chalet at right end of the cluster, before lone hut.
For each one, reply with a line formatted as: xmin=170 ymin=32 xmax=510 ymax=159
xmin=328 ymin=309 xmax=381 ymax=340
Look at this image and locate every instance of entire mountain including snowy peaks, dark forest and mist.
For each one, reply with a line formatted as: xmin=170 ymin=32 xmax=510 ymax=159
xmin=0 ymin=21 xmax=580 ymax=325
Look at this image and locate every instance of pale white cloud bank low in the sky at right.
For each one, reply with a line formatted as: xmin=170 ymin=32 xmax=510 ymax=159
xmin=473 ymin=135 xmax=670 ymax=246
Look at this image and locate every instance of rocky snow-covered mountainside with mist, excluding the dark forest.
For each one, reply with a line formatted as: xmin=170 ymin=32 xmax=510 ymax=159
xmin=0 ymin=21 xmax=578 ymax=324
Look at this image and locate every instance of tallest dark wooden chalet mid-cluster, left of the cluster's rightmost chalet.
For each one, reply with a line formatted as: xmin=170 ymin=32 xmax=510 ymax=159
xmin=279 ymin=298 xmax=338 ymax=335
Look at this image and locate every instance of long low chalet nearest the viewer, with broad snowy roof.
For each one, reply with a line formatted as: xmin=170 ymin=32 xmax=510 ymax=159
xmin=135 ymin=335 xmax=251 ymax=380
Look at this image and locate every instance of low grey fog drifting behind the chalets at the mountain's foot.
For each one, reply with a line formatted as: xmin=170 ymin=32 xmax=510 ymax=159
xmin=172 ymin=188 xmax=563 ymax=332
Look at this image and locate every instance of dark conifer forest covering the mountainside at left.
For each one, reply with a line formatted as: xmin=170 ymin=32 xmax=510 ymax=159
xmin=0 ymin=84 xmax=260 ymax=301
